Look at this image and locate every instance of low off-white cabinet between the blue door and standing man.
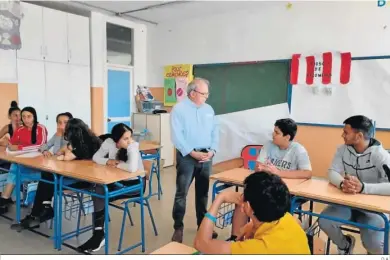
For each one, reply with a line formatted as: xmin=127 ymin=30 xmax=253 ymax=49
xmin=131 ymin=113 xmax=175 ymax=167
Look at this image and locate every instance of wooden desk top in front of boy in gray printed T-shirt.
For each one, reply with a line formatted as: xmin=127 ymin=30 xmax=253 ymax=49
xmin=210 ymin=168 xmax=307 ymax=193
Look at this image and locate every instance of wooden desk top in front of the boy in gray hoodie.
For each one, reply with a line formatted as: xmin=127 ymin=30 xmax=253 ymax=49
xmin=294 ymin=179 xmax=390 ymax=214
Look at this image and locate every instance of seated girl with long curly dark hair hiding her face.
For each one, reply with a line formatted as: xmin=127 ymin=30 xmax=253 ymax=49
xmin=11 ymin=118 xmax=101 ymax=231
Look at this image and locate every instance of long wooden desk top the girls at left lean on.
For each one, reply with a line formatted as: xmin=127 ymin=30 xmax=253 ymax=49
xmin=0 ymin=149 xmax=144 ymax=184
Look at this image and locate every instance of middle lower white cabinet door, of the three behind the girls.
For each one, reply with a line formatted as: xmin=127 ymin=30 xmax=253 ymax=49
xmin=45 ymin=62 xmax=68 ymax=136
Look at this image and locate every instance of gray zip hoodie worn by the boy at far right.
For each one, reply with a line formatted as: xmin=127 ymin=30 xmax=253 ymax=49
xmin=328 ymin=138 xmax=390 ymax=195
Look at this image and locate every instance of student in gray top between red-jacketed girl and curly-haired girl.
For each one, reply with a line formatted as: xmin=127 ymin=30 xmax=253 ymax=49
xmin=39 ymin=112 xmax=73 ymax=157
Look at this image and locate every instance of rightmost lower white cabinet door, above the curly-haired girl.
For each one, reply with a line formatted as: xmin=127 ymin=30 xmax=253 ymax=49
xmin=67 ymin=64 xmax=91 ymax=127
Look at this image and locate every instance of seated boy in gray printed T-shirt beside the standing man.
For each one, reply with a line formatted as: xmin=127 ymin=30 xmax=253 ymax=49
xmin=225 ymin=118 xmax=312 ymax=240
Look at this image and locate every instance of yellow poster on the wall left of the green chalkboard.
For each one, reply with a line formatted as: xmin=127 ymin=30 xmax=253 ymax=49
xmin=164 ymin=64 xmax=193 ymax=106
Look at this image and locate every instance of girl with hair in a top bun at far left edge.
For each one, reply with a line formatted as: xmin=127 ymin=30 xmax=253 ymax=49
xmin=0 ymin=101 xmax=21 ymax=146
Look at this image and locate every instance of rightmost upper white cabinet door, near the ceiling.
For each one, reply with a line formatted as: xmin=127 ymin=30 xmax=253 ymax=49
xmin=67 ymin=14 xmax=90 ymax=66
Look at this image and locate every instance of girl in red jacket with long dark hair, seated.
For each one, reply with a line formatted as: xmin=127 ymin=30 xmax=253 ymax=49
xmin=0 ymin=107 xmax=47 ymax=214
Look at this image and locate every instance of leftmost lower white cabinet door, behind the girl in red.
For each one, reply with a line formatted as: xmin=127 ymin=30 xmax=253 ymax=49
xmin=17 ymin=59 xmax=46 ymax=128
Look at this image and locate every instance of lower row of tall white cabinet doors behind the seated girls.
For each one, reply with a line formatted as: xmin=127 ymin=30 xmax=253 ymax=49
xmin=18 ymin=59 xmax=91 ymax=137
